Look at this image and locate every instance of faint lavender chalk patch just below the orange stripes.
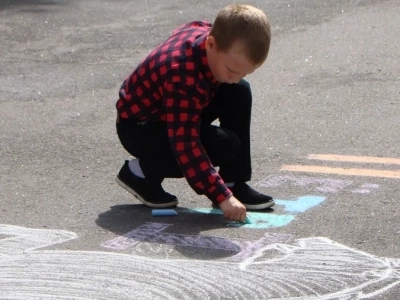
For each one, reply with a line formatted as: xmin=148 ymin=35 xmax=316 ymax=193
xmin=255 ymin=175 xmax=379 ymax=194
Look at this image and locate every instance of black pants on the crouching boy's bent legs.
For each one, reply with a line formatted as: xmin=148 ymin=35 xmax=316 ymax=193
xmin=117 ymin=80 xmax=252 ymax=182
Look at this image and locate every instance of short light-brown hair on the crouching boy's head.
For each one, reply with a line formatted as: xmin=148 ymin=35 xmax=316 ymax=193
xmin=210 ymin=4 xmax=271 ymax=64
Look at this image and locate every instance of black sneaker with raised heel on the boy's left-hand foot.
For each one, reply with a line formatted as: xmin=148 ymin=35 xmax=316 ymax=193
xmin=115 ymin=160 xmax=178 ymax=208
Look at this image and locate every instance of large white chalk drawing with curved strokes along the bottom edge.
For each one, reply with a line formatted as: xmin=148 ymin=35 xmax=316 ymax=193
xmin=0 ymin=225 xmax=400 ymax=300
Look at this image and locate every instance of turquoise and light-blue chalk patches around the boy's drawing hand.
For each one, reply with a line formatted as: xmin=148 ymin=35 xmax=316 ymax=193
xmin=186 ymin=196 xmax=326 ymax=229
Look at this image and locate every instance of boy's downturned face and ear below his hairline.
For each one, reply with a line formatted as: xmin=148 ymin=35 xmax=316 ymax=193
xmin=206 ymin=36 xmax=259 ymax=84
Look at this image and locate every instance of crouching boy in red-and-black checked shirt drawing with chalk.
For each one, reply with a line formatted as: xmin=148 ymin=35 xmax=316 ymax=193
xmin=116 ymin=5 xmax=275 ymax=222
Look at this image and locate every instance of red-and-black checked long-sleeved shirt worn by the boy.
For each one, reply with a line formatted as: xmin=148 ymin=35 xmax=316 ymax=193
xmin=116 ymin=21 xmax=232 ymax=202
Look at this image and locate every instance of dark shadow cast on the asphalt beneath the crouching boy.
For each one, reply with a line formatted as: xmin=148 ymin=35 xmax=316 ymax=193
xmin=96 ymin=204 xmax=274 ymax=260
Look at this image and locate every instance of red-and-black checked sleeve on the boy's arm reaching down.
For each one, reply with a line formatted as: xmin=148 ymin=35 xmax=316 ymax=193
xmin=164 ymin=80 xmax=232 ymax=202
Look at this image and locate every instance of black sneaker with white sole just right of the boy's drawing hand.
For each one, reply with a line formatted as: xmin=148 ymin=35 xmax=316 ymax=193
xmin=229 ymin=182 xmax=275 ymax=210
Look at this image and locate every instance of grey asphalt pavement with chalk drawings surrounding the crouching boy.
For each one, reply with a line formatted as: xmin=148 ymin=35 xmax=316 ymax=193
xmin=0 ymin=0 xmax=400 ymax=300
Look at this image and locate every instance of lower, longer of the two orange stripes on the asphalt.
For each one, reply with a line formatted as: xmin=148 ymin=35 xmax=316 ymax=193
xmin=281 ymin=165 xmax=400 ymax=179
